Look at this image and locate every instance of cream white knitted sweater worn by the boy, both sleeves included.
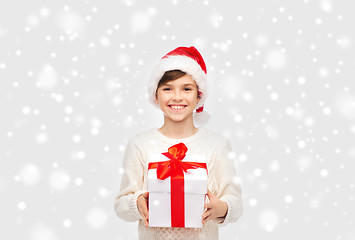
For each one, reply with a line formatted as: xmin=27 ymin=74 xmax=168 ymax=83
xmin=114 ymin=127 xmax=242 ymax=240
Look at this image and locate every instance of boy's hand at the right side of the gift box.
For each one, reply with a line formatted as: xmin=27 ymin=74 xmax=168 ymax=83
xmin=202 ymin=190 xmax=228 ymax=224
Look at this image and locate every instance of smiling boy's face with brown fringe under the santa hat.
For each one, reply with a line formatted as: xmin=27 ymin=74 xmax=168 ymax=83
xmin=155 ymin=74 xmax=199 ymax=122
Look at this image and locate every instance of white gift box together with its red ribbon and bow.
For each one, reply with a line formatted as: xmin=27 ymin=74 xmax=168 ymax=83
xmin=148 ymin=143 xmax=207 ymax=228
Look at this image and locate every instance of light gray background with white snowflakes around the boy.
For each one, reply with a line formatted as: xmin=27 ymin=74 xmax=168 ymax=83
xmin=0 ymin=0 xmax=355 ymax=240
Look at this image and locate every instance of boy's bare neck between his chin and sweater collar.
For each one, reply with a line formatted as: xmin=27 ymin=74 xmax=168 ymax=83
xmin=158 ymin=116 xmax=198 ymax=139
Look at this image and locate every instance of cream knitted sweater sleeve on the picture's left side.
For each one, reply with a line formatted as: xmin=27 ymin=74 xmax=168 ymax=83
xmin=114 ymin=139 xmax=145 ymax=222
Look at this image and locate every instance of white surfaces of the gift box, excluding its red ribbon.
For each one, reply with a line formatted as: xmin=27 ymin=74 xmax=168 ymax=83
xmin=148 ymin=153 xmax=207 ymax=228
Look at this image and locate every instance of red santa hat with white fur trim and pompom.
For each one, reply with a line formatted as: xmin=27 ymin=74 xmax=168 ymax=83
xmin=149 ymin=46 xmax=209 ymax=125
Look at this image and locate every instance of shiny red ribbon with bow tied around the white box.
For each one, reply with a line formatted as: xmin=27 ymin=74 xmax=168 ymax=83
xmin=148 ymin=143 xmax=207 ymax=227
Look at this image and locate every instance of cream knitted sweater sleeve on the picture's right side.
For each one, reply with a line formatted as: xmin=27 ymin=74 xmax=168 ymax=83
xmin=215 ymin=138 xmax=243 ymax=226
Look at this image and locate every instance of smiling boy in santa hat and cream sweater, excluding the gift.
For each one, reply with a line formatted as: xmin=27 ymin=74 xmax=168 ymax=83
xmin=114 ymin=47 xmax=242 ymax=240
